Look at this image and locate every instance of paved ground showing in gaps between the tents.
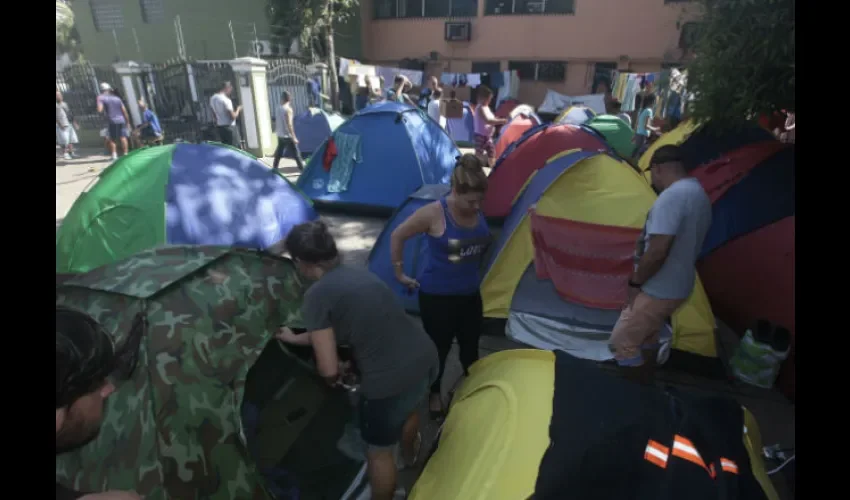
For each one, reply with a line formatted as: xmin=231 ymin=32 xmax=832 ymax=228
xmin=56 ymin=150 xmax=796 ymax=500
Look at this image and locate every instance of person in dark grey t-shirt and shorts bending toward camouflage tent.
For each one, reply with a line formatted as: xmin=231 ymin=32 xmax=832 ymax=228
xmin=277 ymin=221 xmax=438 ymax=500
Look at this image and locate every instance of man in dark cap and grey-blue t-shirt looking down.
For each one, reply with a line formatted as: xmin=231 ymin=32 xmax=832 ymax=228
xmin=609 ymin=146 xmax=711 ymax=383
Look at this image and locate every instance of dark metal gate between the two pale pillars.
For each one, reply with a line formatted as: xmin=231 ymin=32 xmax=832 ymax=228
xmin=142 ymin=60 xmax=245 ymax=147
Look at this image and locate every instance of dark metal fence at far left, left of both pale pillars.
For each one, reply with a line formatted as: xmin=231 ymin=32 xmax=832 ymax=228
xmin=56 ymin=62 xmax=123 ymax=130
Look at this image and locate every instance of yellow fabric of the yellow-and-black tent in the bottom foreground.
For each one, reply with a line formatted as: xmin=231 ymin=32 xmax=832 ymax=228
xmin=408 ymin=349 xmax=779 ymax=500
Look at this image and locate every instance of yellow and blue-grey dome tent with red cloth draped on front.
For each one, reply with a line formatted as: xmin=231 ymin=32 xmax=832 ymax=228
xmin=481 ymin=151 xmax=717 ymax=369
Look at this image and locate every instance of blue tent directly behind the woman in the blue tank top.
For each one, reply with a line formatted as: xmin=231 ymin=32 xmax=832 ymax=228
xmin=369 ymin=184 xmax=451 ymax=314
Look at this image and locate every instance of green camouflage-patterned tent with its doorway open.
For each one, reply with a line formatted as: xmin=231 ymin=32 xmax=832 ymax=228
xmin=56 ymin=246 xmax=363 ymax=500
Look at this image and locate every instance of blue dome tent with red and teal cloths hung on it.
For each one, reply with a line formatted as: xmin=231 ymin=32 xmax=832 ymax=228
xmin=296 ymin=102 xmax=460 ymax=212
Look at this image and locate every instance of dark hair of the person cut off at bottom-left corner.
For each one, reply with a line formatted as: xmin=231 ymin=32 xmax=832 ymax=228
xmin=56 ymin=305 xmax=117 ymax=409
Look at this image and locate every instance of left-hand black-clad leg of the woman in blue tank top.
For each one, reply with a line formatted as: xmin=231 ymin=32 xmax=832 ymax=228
xmin=419 ymin=291 xmax=454 ymax=418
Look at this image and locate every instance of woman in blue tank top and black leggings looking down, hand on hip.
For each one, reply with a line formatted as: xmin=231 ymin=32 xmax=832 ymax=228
xmin=390 ymin=154 xmax=491 ymax=419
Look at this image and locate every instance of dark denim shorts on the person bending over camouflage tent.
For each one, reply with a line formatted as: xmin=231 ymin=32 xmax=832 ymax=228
xmin=358 ymin=374 xmax=432 ymax=448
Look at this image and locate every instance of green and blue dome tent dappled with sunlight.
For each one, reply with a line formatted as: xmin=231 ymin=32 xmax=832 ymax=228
xmin=56 ymin=143 xmax=317 ymax=273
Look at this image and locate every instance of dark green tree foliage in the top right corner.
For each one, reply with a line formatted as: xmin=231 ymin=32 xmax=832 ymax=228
xmin=688 ymin=0 xmax=795 ymax=124
